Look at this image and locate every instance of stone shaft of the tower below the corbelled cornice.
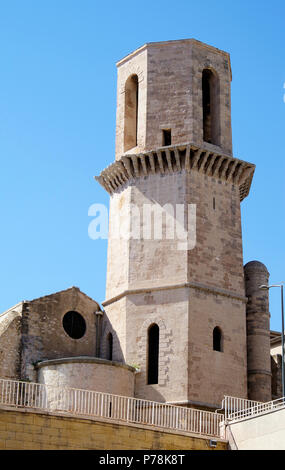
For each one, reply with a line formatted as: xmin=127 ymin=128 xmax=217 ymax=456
xmin=103 ymin=170 xmax=247 ymax=407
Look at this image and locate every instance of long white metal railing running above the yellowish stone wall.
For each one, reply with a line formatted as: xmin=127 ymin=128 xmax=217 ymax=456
xmin=0 ymin=379 xmax=224 ymax=437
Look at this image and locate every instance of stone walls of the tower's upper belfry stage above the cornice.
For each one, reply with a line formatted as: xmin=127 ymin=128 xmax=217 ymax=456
xmin=116 ymin=39 xmax=232 ymax=159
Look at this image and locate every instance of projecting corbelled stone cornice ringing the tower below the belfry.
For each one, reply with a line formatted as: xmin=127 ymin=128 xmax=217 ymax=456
xmin=95 ymin=143 xmax=255 ymax=201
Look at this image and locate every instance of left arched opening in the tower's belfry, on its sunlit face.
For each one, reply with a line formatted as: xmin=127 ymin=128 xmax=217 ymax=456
xmin=124 ymin=75 xmax=139 ymax=152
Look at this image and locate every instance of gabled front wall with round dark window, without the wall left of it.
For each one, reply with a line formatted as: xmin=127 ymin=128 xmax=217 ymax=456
xmin=21 ymin=288 xmax=99 ymax=382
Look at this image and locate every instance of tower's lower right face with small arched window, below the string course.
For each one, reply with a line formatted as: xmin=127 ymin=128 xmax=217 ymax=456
xmin=188 ymin=289 xmax=247 ymax=408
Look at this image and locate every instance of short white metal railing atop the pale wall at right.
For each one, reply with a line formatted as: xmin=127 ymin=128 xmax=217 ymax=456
xmin=224 ymin=396 xmax=285 ymax=423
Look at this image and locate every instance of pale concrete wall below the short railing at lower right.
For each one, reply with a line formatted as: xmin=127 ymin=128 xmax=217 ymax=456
xmin=226 ymin=409 xmax=285 ymax=450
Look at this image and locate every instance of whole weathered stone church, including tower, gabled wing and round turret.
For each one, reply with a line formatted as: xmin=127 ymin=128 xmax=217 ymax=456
xmin=0 ymin=39 xmax=280 ymax=418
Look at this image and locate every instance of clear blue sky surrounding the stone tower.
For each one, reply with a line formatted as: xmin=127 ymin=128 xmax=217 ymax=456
xmin=0 ymin=0 xmax=285 ymax=330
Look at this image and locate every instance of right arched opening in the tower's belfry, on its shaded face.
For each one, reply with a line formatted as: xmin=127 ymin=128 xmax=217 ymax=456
xmin=202 ymin=69 xmax=220 ymax=145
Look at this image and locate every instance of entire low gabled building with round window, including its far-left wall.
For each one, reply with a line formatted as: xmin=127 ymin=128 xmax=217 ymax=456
xmin=0 ymin=287 xmax=100 ymax=385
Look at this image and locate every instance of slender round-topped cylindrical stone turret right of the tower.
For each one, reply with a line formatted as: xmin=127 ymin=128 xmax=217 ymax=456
xmin=244 ymin=261 xmax=272 ymax=402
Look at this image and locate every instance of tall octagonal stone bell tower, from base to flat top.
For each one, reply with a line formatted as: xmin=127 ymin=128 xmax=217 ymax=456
xmin=96 ymin=39 xmax=255 ymax=408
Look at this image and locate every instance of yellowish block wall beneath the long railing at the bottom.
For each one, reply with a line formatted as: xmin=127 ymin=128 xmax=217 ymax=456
xmin=0 ymin=409 xmax=227 ymax=450
